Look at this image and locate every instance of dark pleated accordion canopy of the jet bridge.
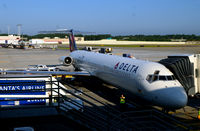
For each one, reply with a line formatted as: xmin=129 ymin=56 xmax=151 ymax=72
xmin=159 ymin=55 xmax=195 ymax=93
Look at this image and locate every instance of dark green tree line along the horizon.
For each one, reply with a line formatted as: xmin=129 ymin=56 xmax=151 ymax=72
xmin=0 ymin=34 xmax=200 ymax=41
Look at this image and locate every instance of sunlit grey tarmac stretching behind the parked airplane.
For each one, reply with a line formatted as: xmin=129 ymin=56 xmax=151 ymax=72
xmin=0 ymin=46 xmax=200 ymax=68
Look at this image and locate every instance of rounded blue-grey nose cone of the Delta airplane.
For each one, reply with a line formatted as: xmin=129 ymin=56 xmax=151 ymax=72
xmin=153 ymin=87 xmax=188 ymax=109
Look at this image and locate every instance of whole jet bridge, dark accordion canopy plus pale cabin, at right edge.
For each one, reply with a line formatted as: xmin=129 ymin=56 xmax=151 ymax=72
xmin=159 ymin=54 xmax=200 ymax=96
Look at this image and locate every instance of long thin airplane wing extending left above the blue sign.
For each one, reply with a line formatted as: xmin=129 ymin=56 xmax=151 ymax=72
xmin=0 ymin=71 xmax=91 ymax=76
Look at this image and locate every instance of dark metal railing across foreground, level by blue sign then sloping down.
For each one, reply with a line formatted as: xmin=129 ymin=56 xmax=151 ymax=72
xmin=0 ymin=78 xmax=189 ymax=130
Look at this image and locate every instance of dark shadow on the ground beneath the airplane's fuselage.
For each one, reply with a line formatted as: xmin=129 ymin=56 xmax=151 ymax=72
xmin=69 ymin=77 xmax=156 ymax=109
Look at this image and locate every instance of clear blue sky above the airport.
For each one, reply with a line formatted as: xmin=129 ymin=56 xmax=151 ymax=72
xmin=0 ymin=0 xmax=200 ymax=35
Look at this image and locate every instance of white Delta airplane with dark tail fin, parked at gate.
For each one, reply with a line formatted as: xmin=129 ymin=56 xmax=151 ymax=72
xmin=0 ymin=30 xmax=188 ymax=110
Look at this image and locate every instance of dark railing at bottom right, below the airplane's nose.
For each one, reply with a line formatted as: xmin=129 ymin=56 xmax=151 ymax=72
xmin=110 ymin=109 xmax=190 ymax=130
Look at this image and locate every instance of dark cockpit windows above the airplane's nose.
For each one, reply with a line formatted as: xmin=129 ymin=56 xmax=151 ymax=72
xmin=146 ymin=74 xmax=176 ymax=82
